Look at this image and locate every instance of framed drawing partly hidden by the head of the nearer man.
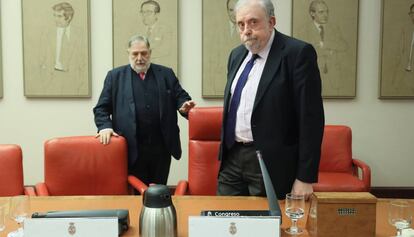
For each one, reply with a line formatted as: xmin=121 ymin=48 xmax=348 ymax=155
xmin=202 ymin=0 xmax=240 ymax=98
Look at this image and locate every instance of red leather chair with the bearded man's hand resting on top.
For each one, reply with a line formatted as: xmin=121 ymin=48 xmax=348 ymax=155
xmin=36 ymin=136 xmax=147 ymax=196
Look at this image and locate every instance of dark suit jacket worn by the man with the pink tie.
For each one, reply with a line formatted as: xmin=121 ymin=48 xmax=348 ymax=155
xmin=93 ymin=63 xmax=191 ymax=165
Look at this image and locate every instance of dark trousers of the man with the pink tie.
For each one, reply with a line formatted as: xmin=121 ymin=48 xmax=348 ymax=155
xmin=129 ymin=145 xmax=171 ymax=185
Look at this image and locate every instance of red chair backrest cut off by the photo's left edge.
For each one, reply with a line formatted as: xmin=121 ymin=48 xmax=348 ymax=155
xmin=0 ymin=144 xmax=24 ymax=196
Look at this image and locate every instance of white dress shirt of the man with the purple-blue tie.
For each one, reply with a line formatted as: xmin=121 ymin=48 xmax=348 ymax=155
xmin=231 ymin=31 xmax=275 ymax=142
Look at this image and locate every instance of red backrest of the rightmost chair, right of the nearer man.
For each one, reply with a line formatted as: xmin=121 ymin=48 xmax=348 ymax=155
xmin=319 ymin=125 xmax=353 ymax=173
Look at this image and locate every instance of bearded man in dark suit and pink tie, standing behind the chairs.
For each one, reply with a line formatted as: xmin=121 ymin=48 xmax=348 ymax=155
xmin=93 ymin=36 xmax=195 ymax=184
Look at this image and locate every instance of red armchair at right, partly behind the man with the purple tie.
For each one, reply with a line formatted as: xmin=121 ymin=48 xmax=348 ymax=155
xmin=313 ymin=125 xmax=371 ymax=192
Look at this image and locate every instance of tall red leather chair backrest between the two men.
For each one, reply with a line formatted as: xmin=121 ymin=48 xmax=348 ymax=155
xmin=188 ymin=107 xmax=223 ymax=195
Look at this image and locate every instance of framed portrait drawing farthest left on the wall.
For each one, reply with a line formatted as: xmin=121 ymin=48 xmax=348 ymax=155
xmin=22 ymin=0 xmax=91 ymax=97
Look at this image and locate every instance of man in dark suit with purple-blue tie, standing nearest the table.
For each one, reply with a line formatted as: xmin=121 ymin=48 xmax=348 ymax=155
xmin=217 ymin=0 xmax=324 ymax=199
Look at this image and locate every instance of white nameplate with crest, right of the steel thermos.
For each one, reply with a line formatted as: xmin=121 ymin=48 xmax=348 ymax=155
xmin=188 ymin=216 xmax=280 ymax=237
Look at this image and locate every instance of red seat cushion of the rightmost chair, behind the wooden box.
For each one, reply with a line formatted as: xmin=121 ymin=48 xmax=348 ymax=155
xmin=313 ymin=172 xmax=367 ymax=192
